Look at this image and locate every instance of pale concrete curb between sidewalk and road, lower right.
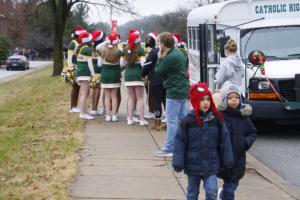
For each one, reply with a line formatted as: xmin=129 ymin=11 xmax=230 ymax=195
xmin=247 ymin=153 xmax=300 ymax=200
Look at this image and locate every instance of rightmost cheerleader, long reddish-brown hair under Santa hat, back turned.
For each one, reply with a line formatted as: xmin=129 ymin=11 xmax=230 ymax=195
xmin=121 ymin=30 xmax=148 ymax=126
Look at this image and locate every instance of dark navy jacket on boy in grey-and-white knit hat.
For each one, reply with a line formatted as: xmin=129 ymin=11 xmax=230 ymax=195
xmin=219 ymin=109 xmax=257 ymax=180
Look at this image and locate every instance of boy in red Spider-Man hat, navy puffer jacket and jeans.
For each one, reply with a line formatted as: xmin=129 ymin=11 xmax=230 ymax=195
xmin=172 ymin=83 xmax=233 ymax=200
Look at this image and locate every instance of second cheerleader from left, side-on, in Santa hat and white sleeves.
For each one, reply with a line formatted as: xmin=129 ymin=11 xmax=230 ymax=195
xmin=76 ymin=32 xmax=95 ymax=120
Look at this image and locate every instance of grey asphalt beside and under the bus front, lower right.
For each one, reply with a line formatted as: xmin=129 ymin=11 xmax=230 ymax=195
xmin=250 ymin=124 xmax=300 ymax=190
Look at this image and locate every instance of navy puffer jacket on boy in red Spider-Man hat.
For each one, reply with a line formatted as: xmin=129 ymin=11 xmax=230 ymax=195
xmin=172 ymin=110 xmax=233 ymax=177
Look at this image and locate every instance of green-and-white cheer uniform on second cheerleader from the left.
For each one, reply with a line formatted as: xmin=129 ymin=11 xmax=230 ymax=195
xmin=76 ymin=45 xmax=92 ymax=81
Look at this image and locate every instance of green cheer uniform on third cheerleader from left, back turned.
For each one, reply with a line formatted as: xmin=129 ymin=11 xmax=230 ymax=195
xmin=101 ymin=51 xmax=121 ymax=88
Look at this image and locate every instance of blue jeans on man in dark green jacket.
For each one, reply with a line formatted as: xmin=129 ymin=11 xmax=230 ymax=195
xmin=162 ymin=98 xmax=187 ymax=152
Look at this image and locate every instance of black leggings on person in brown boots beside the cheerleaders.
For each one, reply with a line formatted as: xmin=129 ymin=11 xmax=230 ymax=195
xmin=149 ymin=85 xmax=166 ymax=118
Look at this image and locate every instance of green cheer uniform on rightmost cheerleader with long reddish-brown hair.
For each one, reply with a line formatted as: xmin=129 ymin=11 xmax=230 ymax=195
xmin=125 ymin=47 xmax=145 ymax=86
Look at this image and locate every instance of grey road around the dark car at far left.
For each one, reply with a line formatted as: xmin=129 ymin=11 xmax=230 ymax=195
xmin=0 ymin=61 xmax=52 ymax=80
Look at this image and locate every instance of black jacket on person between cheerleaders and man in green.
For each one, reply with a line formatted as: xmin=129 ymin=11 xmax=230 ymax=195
xmin=143 ymin=48 xmax=163 ymax=86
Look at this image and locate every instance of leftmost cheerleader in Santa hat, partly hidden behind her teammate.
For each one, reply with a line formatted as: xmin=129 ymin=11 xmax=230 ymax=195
xmin=67 ymin=26 xmax=86 ymax=113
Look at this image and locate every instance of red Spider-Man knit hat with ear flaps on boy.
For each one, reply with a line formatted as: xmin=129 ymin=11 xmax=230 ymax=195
xmin=190 ymin=82 xmax=224 ymax=126
